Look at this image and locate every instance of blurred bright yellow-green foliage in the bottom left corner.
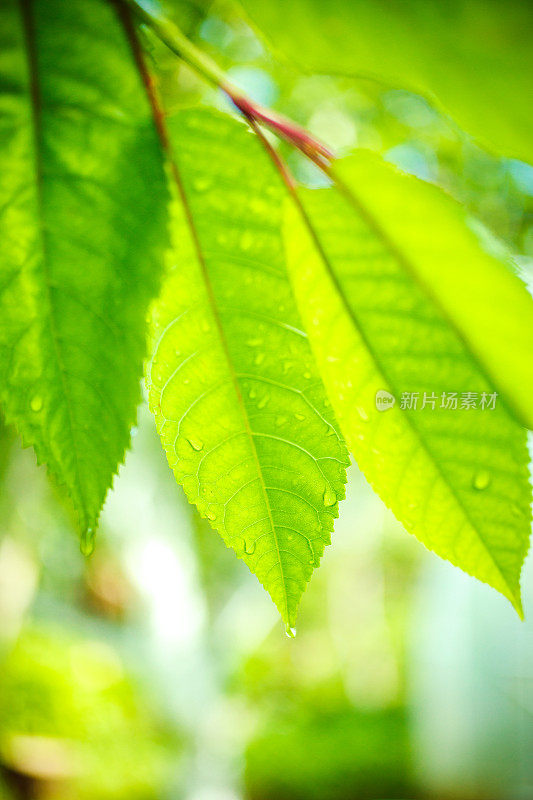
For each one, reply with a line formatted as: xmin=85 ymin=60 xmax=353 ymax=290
xmin=0 ymin=626 xmax=179 ymax=800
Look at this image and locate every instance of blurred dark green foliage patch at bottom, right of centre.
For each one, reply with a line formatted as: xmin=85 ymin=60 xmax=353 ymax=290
xmin=246 ymin=708 xmax=413 ymax=800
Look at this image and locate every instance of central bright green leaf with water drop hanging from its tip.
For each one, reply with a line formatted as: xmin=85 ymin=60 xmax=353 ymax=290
xmin=148 ymin=110 xmax=348 ymax=627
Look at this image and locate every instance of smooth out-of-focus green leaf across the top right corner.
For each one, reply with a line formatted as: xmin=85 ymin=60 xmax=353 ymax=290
xmin=241 ymin=0 xmax=533 ymax=162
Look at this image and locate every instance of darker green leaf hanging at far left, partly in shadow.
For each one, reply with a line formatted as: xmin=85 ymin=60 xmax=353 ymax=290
xmin=0 ymin=0 xmax=166 ymax=538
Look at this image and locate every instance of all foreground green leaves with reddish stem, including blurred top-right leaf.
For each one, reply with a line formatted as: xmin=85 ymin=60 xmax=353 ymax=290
xmin=0 ymin=0 xmax=533 ymax=630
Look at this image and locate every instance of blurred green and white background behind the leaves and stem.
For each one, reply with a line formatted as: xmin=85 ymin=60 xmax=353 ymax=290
xmin=0 ymin=0 xmax=533 ymax=800
